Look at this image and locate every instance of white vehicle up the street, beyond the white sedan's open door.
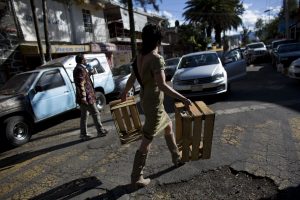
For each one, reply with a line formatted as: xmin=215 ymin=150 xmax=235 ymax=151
xmin=245 ymin=42 xmax=269 ymax=64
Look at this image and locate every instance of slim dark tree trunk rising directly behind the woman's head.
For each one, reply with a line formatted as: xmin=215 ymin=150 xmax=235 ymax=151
xmin=121 ymin=0 xmax=162 ymax=58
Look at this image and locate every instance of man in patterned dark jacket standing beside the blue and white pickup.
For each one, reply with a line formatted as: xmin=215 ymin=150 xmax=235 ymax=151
xmin=73 ymin=54 xmax=108 ymax=140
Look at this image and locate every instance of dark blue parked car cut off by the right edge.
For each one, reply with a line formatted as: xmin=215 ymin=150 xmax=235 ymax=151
xmin=275 ymin=43 xmax=300 ymax=74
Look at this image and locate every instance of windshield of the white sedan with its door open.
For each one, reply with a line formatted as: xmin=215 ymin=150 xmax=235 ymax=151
xmin=178 ymin=53 xmax=219 ymax=69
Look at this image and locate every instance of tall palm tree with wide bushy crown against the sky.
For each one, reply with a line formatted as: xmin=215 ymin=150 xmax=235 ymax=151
xmin=183 ymin=0 xmax=244 ymax=47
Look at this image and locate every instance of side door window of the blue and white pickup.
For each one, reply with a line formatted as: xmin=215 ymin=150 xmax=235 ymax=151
xmin=37 ymin=70 xmax=65 ymax=90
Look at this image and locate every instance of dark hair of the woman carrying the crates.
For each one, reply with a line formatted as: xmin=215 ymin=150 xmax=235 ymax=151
xmin=142 ymin=23 xmax=162 ymax=55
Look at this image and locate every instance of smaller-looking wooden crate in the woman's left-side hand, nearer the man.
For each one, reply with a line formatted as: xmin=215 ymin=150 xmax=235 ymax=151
xmin=109 ymin=97 xmax=142 ymax=144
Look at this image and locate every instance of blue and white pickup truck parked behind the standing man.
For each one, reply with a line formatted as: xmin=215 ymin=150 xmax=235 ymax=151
xmin=0 ymin=54 xmax=114 ymax=146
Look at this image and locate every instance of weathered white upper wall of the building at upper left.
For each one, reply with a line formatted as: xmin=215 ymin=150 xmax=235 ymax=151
xmin=13 ymin=0 xmax=109 ymax=44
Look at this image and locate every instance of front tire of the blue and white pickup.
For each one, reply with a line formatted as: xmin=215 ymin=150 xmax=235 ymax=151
xmin=4 ymin=116 xmax=32 ymax=147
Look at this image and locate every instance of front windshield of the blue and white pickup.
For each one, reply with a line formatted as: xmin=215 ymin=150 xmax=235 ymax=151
xmin=0 ymin=72 xmax=38 ymax=94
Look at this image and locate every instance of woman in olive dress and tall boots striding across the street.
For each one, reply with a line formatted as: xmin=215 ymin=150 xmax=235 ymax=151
xmin=121 ymin=24 xmax=191 ymax=187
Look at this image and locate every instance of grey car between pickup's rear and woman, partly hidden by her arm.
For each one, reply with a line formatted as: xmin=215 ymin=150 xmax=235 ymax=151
xmin=109 ymin=63 xmax=141 ymax=99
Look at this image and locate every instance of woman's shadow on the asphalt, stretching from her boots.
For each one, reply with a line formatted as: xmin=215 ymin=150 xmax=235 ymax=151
xmin=88 ymin=166 xmax=177 ymax=200
